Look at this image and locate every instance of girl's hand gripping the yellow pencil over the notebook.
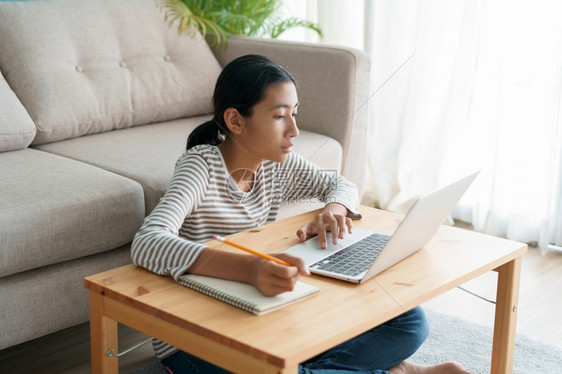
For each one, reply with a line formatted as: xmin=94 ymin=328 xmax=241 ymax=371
xmin=252 ymin=253 xmax=310 ymax=296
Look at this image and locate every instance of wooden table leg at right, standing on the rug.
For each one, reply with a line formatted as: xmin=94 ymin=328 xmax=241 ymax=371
xmin=491 ymin=257 xmax=521 ymax=374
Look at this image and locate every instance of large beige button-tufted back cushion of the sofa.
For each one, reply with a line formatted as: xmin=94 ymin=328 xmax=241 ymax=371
xmin=0 ymin=0 xmax=221 ymax=144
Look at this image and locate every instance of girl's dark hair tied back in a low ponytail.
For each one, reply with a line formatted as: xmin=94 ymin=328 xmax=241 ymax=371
xmin=186 ymin=55 xmax=295 ymax=149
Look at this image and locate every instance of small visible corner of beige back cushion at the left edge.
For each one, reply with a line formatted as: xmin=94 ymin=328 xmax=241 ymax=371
xmin=0 ymin=70 xmax=35 ymax=152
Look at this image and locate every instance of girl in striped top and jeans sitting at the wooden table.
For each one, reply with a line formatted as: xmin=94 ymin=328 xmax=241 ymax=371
xmin=131 ymin=55 xmax=468 ymax=374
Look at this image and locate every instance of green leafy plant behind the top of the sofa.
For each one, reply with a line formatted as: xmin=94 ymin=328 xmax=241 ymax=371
xmin=157 ymin=0 xmax=322 ymax=44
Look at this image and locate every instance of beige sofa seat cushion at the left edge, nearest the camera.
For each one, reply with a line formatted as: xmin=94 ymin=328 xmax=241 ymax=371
xmin=0 ymin=148 xmax=144 ymax=277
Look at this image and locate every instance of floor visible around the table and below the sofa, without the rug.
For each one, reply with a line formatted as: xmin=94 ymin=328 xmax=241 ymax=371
xmin=0 ymin=241 xmax=562 ymax=374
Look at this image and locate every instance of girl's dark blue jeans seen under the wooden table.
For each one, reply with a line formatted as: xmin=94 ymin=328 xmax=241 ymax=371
xmin=162 ymin=307 xmax=429 ymax=374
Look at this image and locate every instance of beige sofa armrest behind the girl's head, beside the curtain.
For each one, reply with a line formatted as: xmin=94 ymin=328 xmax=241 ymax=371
xmin=213 ymin=36 xmax=370 ymax=193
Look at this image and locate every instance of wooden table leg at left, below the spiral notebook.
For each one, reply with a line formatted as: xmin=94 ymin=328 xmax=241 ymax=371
xmin=90 ymin=291 xmax=119 ymax=374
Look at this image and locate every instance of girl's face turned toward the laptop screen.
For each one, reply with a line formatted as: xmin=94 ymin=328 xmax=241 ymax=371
xmin=240 ymin=81 xmax=299 ymax=162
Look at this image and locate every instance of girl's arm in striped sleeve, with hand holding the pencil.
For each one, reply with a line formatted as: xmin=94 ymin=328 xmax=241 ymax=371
xmin=131 ymin=151 xmax=308 ymax=295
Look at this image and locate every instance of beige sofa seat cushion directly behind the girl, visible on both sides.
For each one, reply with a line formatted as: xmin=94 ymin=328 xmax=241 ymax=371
xmin=37 ymin=116 xmax=342 ymax=214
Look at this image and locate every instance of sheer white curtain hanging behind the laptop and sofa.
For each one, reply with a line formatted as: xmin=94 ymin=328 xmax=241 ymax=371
xmin=284 ymin=0 xmax=562 ymax=248
